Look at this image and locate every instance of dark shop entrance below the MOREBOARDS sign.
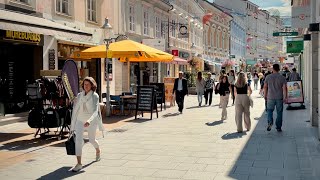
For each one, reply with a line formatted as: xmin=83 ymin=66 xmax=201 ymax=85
xmin=0 ymin=42 xmax=43 ymax=114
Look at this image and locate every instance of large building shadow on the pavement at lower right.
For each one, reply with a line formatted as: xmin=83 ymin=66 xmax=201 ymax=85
xmin=226 ymin=100 xmax=320 ymax=180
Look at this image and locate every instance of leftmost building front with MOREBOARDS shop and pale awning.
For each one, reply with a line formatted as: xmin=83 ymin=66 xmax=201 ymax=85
xmin=0 ymin=0 xmax=117 ymax=113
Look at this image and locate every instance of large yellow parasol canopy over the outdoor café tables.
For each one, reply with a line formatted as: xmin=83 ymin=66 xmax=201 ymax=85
xmin=74 ymin=40 xmax=173 ymax=62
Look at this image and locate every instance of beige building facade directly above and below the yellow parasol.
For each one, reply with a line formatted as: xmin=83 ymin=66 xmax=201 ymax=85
xmin=115 ymin=0 xmax=171 ymax=94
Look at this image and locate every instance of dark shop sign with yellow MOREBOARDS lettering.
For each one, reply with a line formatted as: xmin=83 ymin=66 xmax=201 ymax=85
xmin=0 ymin=30 xmax=43 ymax=46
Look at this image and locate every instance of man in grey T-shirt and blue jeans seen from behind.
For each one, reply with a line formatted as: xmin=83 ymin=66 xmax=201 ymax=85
xmin=264 ymin=64 xmax=287 ymax=132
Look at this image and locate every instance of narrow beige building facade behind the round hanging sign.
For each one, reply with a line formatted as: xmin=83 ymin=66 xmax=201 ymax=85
xmin=170 ymin=0 xmax=204 ymax=74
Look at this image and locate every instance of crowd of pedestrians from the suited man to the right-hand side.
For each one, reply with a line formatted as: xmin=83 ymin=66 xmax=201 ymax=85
xmin=173 ymin=64 xmax=301 ymax=133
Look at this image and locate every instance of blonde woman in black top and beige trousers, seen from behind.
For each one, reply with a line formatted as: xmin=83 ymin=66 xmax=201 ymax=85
xmin=234 ymin=72 xmax=252 ymax=133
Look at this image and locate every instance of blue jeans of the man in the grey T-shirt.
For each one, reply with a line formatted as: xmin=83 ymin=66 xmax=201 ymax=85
xmin=267 ymin=99 xmax=283 ymax=129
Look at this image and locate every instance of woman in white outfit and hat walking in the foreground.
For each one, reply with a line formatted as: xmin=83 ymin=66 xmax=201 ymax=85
xmin=71 ymin=77 xmax=104 ymax=172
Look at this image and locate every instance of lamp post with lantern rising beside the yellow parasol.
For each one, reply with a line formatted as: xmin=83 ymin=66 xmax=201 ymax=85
xmin=102 ymin=18 xmax=113 ymax=117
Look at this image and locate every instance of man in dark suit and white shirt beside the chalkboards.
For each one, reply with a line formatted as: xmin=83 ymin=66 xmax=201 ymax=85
xmin=173 ymin=71 xmax=188 ymax=114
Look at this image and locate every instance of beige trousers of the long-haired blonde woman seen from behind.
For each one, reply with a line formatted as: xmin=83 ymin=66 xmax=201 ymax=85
xmin=235 ymin=94 xmax=251 ymax=132
